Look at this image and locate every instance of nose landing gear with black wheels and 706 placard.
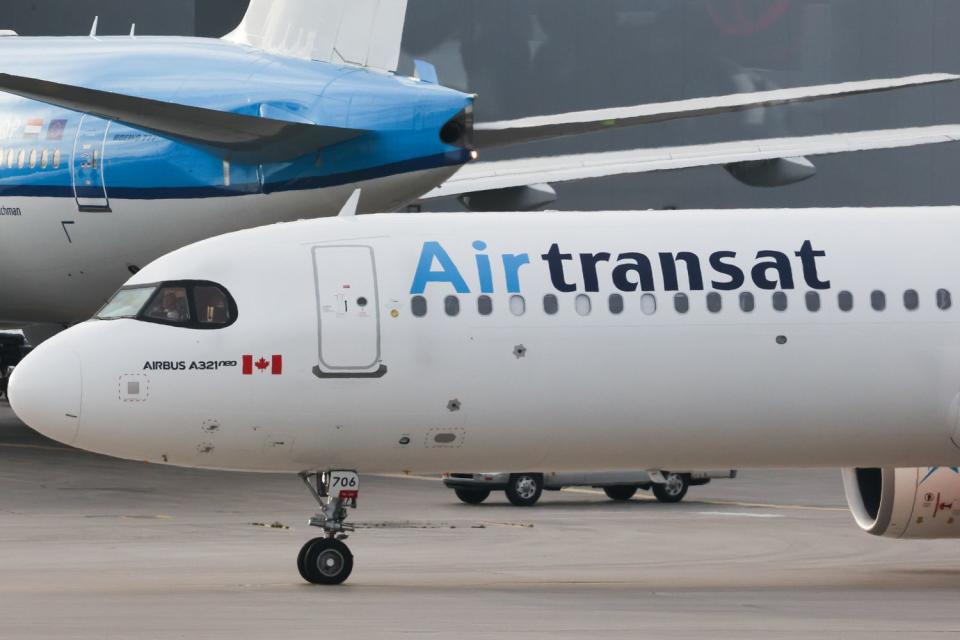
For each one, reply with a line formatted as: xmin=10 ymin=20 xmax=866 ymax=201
xmin=297 ymin=471 xmax=360 ymax=584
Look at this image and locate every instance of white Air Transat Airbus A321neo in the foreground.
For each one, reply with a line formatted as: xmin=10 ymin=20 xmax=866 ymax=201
xmin=10 ymin=206 xmax=960 ymax=583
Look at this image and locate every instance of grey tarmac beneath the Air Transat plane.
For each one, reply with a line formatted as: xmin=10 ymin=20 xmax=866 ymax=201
xmin=0 ymin=404 xmax=960 ymax=640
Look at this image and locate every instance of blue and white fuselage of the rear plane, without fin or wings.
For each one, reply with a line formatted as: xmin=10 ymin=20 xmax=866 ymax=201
xmin=0 ymin=37 xmax=473 ymax=326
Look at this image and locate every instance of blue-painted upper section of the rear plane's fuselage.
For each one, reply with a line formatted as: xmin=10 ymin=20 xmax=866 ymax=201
xmin=0 ymin=37 xmax=471 ymax=205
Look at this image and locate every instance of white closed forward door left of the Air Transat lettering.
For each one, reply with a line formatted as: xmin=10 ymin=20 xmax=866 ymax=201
xmin=313 ymin=245 xmax=387 ymax=378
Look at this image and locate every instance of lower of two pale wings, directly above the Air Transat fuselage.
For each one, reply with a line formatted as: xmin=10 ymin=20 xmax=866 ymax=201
xmin=424 ymin=124 xmax=960 ymax=199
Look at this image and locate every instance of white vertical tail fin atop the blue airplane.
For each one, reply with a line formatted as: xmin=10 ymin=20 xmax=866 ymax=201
xmin=225 ymin=0 xmax=407 ymax=71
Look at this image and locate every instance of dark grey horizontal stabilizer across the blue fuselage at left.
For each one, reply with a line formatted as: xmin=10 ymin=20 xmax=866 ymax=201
xmin=0 ymin=74 xmax=363 ymax=162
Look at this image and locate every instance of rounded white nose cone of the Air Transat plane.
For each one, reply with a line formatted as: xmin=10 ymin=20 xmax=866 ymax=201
xmin=7 ymin=339 xmax=83 ymax=444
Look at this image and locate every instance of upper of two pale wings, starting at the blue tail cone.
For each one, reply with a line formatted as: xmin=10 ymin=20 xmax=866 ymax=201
xmin=474 ymin=73 xmax=960 ymax=149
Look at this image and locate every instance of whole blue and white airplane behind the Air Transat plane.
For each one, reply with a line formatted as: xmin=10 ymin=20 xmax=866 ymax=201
xmin=0 ymin=0 xmax=957 ymax=335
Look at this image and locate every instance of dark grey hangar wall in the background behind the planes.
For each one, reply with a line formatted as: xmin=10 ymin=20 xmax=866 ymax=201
xmin=7 ymin=0 xmax=960 ymax=208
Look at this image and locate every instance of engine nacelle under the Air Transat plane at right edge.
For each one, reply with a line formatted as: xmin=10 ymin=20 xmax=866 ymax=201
xmin=843 ymin=467 xmax=960 ymax=539
